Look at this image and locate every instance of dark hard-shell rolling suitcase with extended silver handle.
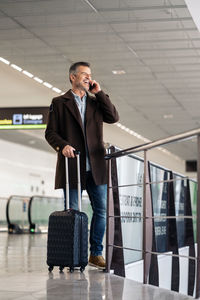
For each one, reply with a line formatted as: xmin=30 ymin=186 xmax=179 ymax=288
xmin=47 ymin=152 xmax=88 ymax=272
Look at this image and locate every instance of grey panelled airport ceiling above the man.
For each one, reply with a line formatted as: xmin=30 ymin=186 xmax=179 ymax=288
xmin=0 ymin=0 xmax=200 ymax=159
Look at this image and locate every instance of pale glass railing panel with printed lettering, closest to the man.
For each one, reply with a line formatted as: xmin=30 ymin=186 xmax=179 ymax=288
xmin=117 ymin=156 xmax=144 ymax=264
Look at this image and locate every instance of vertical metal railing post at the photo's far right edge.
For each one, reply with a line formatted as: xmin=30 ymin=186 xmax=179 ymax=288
xmin=196 ymin=135 xmax=200 ymax=298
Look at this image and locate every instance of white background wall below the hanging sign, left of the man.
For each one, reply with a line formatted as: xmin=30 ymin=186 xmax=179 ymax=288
xmin=0 ymin=140 xmax=62 ymax=197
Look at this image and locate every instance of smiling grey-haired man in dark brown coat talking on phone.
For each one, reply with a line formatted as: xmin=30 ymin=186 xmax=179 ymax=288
xmin=45 ymin=62 xmax=119 ymax=269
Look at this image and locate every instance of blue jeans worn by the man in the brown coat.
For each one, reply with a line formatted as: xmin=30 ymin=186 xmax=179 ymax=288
xmin=64 ymin=172 xmax=107 ymax=256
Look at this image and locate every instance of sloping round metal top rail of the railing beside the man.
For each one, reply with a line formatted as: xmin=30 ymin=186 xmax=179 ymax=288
xmin=105 ymin=128 xmax=200 ymax=159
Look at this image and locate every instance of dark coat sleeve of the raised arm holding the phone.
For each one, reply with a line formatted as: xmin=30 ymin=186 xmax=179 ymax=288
xmin=95 ymin=91 xmax=119 ymax=124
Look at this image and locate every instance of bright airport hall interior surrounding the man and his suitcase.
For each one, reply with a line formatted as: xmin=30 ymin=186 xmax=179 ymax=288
xmin=0 ymin=0 xmax=200 ymax=300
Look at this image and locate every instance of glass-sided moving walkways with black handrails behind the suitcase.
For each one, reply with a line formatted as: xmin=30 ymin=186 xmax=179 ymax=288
xmin=5 ymin=193 xmax=92 ymax=233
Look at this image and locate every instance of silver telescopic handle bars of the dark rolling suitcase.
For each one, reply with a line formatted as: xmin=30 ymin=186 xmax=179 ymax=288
xmin=65 ymin=150 xmax=81 ymax=211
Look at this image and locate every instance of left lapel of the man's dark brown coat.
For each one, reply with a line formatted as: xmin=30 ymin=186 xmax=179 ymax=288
xmin=63 ymin=90 xmax=84 ymax=134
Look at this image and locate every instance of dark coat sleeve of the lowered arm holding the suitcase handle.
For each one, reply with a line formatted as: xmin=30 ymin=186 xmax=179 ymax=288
xmin=45 ymin=99 xmax=70 ymax=152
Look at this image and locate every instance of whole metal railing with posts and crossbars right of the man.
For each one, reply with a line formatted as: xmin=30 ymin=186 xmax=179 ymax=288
xmin=105 ymin=128 xmax=200 ymax=298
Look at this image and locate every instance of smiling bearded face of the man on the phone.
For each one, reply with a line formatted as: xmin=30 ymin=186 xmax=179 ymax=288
xmin=70 ymin=66 xmax=91 ymax=91
